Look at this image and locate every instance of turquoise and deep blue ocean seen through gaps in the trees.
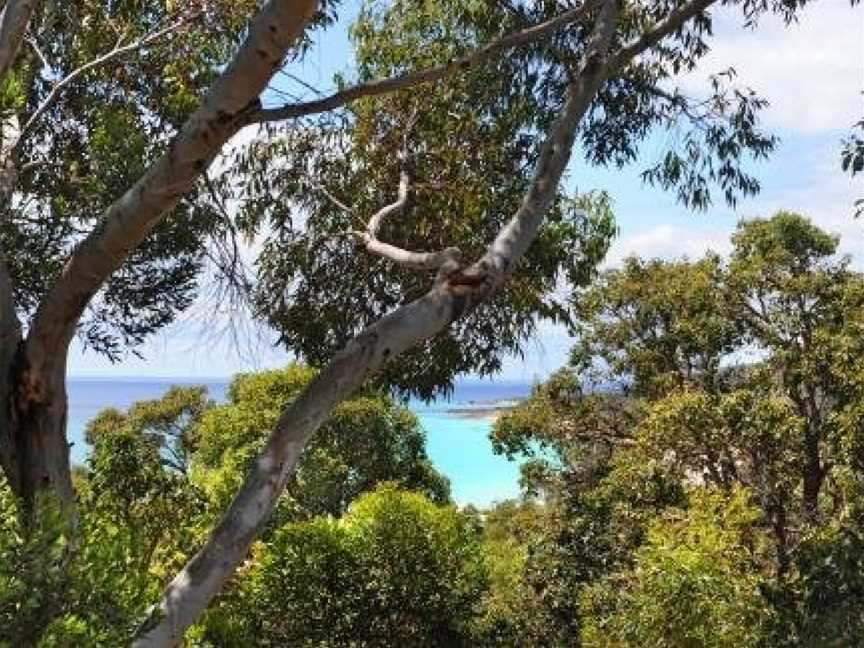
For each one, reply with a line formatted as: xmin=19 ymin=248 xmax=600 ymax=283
xmin=67 ymin=378 xmax=531 ymax=507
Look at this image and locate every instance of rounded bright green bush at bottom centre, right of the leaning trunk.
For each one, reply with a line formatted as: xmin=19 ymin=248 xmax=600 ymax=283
xmin=210 ymin=483 xmax=486 ymax=647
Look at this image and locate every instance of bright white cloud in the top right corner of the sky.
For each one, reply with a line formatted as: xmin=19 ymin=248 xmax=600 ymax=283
xmin=681 ymin=0 xmax=864 ymax=132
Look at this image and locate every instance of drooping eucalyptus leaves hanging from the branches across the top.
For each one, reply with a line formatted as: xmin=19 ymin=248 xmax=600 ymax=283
xmin=0 ymin=0 xmax=796 ymax=395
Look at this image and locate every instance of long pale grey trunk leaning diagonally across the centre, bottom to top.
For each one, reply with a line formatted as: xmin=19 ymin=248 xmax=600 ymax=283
xmin=134 ymin=0 xmax=618 ymax=648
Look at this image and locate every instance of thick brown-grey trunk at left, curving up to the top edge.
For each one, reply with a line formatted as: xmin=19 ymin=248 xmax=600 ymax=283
xmin=6 ymin=0 xmax=318 ymax=529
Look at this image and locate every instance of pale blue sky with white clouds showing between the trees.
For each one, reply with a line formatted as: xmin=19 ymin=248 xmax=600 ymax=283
xmin=69 ymin=0 xmax=864 ymax=381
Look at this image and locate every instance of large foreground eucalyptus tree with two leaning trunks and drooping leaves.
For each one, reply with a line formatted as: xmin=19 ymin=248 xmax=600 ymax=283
xmin=0 ymin=0 xmax=832 ymax=645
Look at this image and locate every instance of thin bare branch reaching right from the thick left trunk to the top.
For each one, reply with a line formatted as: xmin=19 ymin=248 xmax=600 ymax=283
xmin=249 ymin=0 xmax=600 ymax=123
